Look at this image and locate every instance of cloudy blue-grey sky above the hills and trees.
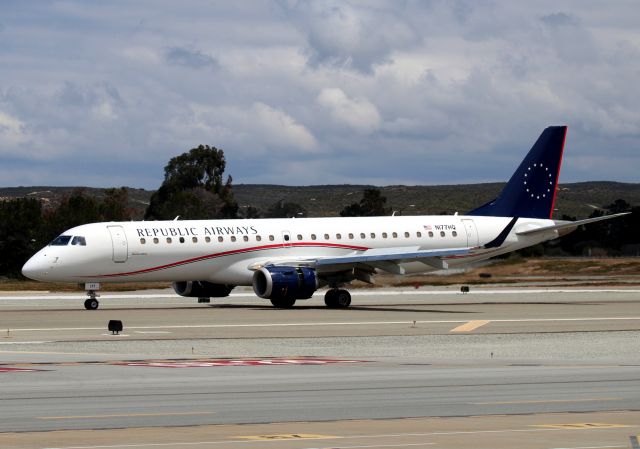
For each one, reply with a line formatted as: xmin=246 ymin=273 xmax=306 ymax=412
xmin=0 ymin=0 xmax=640 ymax=189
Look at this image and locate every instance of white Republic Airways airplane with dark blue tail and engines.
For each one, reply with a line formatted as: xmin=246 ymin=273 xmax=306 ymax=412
xmin=22 ymin=126 xmax=626 ymax=310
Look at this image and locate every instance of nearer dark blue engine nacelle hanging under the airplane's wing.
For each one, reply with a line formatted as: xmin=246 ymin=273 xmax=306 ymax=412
xmin=253 ymin=267 xmax=318 ymax=299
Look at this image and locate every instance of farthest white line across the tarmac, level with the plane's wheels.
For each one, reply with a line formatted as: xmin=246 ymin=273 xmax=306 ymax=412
xmin=0 ymin=288 xmax=640 ymax=301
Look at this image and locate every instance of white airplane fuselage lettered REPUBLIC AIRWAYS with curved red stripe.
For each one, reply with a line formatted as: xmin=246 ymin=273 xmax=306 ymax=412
xmin=23 ymin=215 xmax=558 ymax=285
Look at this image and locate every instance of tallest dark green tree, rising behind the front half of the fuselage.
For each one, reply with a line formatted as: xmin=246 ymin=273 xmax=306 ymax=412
xmin=145 ymin=145 xmax=238 ymax=220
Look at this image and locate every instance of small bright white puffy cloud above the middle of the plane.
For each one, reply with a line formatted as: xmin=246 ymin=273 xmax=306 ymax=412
xmin=317 ymin=87 xmax=381 ymax=133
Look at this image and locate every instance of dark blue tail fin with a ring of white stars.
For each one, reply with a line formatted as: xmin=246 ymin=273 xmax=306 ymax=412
xmin=467 ymin=126 xmax=567 ymax=218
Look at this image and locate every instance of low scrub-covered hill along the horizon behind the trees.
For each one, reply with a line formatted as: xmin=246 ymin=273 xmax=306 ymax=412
xmin=0 ymin=181 xmax=640 ymax=218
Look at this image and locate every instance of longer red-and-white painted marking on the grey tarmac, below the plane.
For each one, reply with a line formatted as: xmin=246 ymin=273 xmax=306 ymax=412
xmin=115 ymin=358 xmax=362 ymax=368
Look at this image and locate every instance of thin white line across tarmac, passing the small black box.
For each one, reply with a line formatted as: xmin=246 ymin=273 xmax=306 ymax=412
xmin=0 ymin=316 xmax=640 ymax=332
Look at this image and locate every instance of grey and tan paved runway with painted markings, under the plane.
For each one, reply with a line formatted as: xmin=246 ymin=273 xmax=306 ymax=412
xmin=0 ymin=289 xmax=640 ymax=448
